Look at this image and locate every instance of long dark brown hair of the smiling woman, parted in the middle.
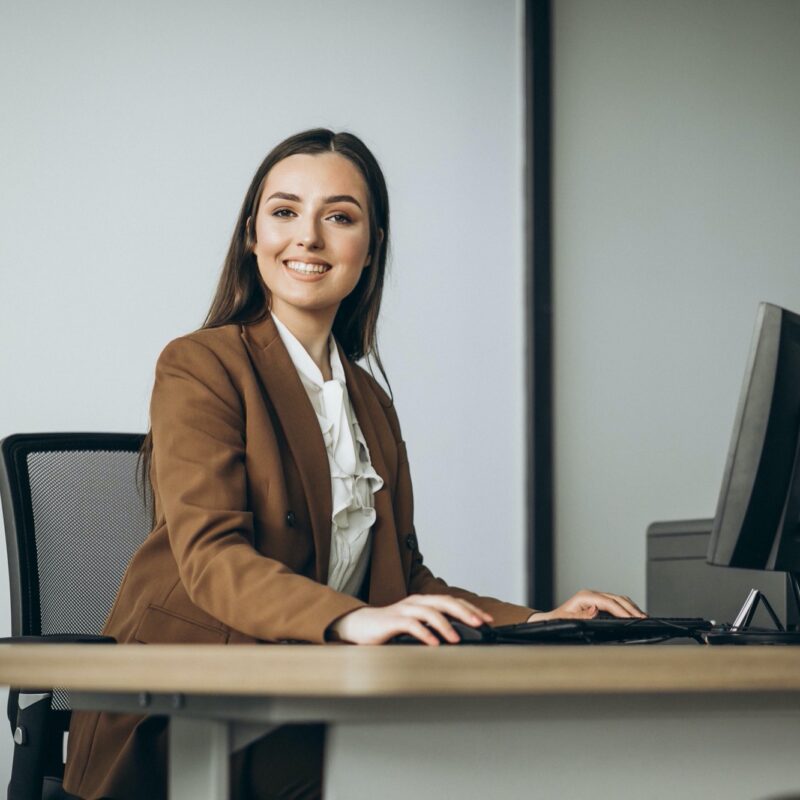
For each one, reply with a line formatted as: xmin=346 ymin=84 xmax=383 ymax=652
xmin=137 ymin=128 xmax=391 ymax=513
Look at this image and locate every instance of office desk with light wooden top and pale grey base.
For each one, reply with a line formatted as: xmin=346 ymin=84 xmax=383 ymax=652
xmin=0 ymin=645 xmax=800 ymax=800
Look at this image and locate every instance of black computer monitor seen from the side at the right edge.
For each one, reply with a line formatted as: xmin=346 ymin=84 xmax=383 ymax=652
xmin=706 ymin=303 xmax=800 ymax=620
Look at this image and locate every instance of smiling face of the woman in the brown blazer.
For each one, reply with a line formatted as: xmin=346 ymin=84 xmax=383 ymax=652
xmin=253 ymin=153 xmax=376 ymax=326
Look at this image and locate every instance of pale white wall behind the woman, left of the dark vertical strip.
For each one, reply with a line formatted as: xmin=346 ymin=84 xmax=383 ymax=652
xmin=0 ymin=0 xmax=524 ymax=783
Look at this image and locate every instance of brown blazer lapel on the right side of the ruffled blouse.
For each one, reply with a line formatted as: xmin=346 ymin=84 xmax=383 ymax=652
xmin=336 ymin=342 xmax=408 ymax=606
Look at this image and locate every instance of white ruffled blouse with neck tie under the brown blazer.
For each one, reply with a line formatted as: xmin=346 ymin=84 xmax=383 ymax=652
xmin=272 ymin=314 xmax=383 ymax=596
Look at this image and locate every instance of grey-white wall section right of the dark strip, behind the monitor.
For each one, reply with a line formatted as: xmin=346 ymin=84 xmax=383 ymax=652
xmin=554 ymin=0 xmax=800 ymax=600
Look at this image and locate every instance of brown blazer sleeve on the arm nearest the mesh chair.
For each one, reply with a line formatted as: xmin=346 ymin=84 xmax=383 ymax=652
xmin=150 ymin=337 xmax=364 ymax=642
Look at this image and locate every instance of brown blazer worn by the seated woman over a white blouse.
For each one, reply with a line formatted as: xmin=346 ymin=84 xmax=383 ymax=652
xmin=64 ymin=317 xmax=531 ymax=799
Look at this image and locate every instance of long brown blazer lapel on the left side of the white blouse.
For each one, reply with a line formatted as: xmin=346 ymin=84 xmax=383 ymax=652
xmin=241 ymin=316 xmax=332 ymax=583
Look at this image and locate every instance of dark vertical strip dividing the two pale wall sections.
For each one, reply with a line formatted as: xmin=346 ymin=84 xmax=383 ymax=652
xmin=523 ymin=0 xmax=554 ymax=609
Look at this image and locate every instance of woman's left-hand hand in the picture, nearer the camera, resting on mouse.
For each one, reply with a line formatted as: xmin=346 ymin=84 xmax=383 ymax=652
xmin=328 ymin=594 xmax=492 ymax=646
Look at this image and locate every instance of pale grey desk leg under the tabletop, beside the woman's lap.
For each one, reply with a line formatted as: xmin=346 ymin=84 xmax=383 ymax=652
xmin=169 ymin=716 xmax=230 ymax=800
